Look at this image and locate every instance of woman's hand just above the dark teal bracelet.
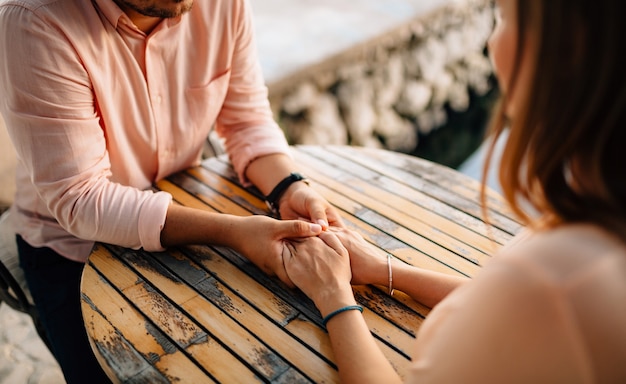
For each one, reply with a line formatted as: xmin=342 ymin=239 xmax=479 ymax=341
xmin=283 ymin=232 xmax=355 ymax=316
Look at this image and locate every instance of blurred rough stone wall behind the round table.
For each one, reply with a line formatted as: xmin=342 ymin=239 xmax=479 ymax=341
xmin=269 ymin=0 xmax=493 ymax=152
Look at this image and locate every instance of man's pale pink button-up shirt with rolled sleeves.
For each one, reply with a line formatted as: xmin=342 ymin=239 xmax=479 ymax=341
xmin=0 ymin=0 xmax=288 ymax=261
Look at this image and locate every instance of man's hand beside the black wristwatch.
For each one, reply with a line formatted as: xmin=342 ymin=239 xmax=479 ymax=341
xmin=279 ymin=182 xmax=344 ymax=230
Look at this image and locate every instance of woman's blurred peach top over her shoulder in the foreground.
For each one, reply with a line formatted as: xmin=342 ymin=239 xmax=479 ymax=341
xmin=407 ymin=225 xmax=626 ymax=384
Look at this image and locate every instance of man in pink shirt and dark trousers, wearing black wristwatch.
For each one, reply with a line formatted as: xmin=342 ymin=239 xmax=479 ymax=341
xmin=0 ymin=0 xmax=341 ymax=383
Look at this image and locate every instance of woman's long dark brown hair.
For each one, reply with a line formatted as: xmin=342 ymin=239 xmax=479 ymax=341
xmin=481 ymin=0 xmax=626 ymax=241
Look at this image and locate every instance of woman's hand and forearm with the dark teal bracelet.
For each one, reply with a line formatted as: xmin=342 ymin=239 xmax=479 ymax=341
xmin=283 ymin=232 xmax=400 ymax=383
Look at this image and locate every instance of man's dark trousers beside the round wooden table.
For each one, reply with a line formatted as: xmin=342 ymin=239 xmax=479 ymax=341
xmin=17 ymin=235 xmax=110 ymax=384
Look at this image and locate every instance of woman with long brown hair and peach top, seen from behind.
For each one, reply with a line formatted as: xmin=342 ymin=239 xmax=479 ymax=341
xmin=283 ymin=0 xmax=626 ymax=383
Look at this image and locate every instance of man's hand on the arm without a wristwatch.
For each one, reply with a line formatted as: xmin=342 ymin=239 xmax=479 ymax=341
xmin=230 ymin=215 xmax=322 ymax=288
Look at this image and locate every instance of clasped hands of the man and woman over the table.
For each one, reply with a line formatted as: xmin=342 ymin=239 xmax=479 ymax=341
xmin=230 ymin=184 xmax=380 ymax=304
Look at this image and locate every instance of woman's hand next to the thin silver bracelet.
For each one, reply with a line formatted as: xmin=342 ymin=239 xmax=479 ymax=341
xmin=329 ymin=227 xmax=389 ymax=285
